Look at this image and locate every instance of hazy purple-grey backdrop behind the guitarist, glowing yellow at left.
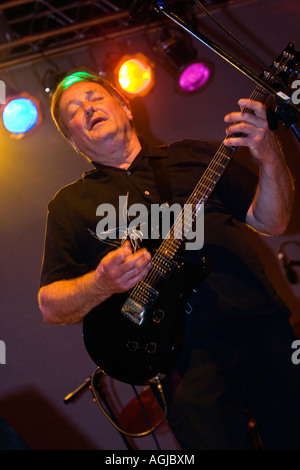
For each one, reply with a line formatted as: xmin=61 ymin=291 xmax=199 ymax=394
xmin=0 ymin=0 xmax=300 ymax=450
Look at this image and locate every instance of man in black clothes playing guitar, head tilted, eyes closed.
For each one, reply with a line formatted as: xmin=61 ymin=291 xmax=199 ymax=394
xmin=39 ymin=73 xmax=300 ymax=450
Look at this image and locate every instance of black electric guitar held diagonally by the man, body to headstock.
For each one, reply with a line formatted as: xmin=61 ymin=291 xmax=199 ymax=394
xmin=83 ymin=44 xmax=300 ymax=385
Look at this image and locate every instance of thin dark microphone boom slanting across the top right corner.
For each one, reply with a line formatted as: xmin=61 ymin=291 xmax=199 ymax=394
xmin=152 ymin=0 xmax=300 ymax=142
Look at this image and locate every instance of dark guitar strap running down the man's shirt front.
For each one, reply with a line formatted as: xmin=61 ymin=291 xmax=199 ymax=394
xmin=149 ymin=153 xmax=172 ymax=206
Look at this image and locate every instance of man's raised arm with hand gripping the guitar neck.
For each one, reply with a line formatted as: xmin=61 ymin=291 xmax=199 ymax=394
xmin=225 ymin=99 xmax=294 ymax=236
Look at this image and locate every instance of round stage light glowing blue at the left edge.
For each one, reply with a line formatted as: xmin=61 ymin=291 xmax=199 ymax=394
xmin=2 ymin=93 xmax=42 ymax=139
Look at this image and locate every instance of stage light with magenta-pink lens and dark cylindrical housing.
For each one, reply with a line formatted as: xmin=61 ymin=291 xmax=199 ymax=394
xmin=154 ymin=36 xmax=212 ymax=93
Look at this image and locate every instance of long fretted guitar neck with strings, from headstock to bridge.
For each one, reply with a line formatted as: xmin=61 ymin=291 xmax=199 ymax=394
xmin=119 ymin=43 xmax=300 ymax=323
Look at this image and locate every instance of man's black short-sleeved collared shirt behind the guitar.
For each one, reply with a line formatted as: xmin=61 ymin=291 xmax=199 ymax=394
xmin=41 ymin=140 xmax=288 ymax=318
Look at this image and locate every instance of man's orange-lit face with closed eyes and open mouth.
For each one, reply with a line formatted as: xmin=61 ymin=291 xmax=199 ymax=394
xmin=60 ymin=82 xmax=132 ymax=164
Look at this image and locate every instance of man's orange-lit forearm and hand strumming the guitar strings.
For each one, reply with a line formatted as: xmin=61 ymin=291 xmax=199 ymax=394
xmin=39 ymin=242 xmax=150 ymax=324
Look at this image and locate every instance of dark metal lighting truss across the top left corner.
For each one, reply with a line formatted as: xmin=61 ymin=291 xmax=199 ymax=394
xmin=0 ymin=0 xmax=251 ymax=70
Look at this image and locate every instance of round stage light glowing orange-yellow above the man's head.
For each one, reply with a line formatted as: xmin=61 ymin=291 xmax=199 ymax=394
xmin=115 ymin=54 xmax=155 ymax=97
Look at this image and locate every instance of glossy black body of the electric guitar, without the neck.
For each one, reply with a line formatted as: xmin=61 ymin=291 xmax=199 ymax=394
xmin=83 ymin=263 xmax=206 ymax=385
